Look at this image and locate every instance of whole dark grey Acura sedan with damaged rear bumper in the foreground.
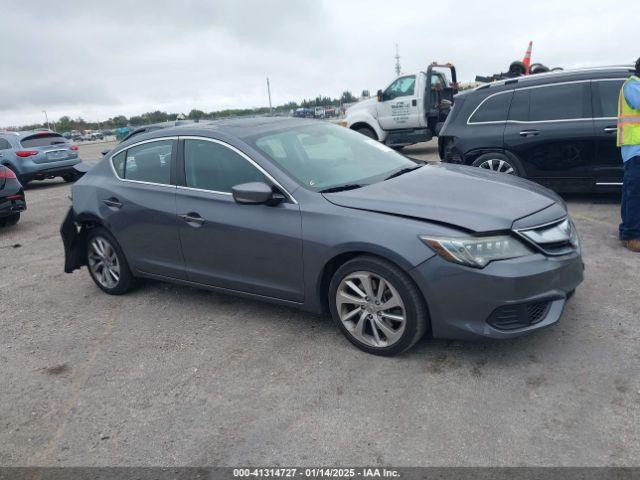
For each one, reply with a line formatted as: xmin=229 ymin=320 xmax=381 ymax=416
xmin=61 ymin=118 xmax=583 ymax=355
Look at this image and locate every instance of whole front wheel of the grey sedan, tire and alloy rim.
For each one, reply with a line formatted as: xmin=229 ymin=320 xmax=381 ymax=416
xmin=329 ymin=257 xmax=427 ymax=356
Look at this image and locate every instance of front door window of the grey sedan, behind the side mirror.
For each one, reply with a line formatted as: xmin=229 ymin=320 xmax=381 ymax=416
xmin=184 ymin=139 xmax=266 ymax=193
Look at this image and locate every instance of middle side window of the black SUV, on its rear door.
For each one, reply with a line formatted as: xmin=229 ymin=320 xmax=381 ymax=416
xmin=529 ymin=82 xmax=592 ymax=122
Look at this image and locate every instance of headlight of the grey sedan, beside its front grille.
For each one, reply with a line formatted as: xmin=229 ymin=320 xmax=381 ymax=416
xmin=420 ymin=235 xmax=533 ymax=268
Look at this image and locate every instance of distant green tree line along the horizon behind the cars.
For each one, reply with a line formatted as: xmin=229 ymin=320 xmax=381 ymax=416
xmin=12 ymin=91 xmax=358 ymax=132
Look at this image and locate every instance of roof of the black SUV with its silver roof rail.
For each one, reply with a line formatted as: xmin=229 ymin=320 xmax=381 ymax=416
xmin=461 ymin=65 xmax=634 ymax=95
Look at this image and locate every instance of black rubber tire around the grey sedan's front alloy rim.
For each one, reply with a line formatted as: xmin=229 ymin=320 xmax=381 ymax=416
xmin=328 ymin=256 xmax=429 ymax=357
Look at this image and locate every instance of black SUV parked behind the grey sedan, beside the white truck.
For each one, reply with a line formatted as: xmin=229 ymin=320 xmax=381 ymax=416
xmin=438 ymin=66 xmax=633 ymax=192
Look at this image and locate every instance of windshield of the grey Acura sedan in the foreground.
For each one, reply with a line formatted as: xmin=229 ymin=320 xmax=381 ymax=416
xmin=249 ymin=122 xmax=416 ymax=192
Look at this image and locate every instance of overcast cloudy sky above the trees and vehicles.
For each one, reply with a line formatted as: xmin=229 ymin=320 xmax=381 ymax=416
xmin=0 ymin=0 xmax=640 ymax=126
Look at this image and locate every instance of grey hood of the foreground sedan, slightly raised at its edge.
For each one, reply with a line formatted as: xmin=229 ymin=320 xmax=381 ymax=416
xmin=324 ymin=164 xmax=566 ymax=232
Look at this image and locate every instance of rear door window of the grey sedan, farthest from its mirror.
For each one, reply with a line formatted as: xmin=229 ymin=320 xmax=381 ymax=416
xmin=111 ymin=140 xmax=175 ymax=185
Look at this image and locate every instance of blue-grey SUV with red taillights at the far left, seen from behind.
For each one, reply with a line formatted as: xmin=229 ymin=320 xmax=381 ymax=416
xmin=0 ymin=131 xmax=80 ymax=185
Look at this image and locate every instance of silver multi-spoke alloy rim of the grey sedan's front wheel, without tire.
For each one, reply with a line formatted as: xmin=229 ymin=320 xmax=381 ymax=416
xmin=336 ymin=271 xmax=406 ymax=348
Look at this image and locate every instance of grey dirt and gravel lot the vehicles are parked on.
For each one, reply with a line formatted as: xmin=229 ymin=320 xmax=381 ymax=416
xmin=0 ymin=138 xmax=640 ymax=466
